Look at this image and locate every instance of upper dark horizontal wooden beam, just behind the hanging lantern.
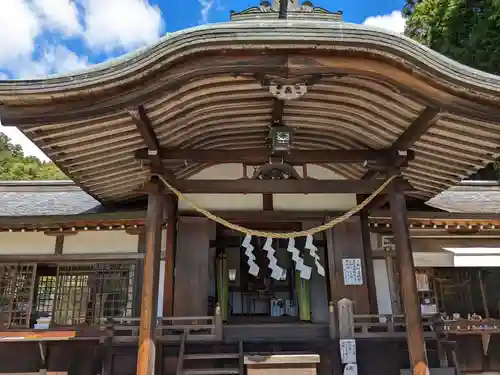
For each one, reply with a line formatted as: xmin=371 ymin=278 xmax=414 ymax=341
xmin=135 ymin=148 xmax=397 ymax=165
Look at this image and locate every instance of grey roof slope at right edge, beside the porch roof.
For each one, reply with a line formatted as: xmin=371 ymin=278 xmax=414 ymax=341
xmin=427 ymin=181 xmax=500 ymax=213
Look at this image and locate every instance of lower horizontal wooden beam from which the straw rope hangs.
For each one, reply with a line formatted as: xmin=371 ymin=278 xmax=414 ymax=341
xmin=172 ymin=179 xmax=414 ymax=194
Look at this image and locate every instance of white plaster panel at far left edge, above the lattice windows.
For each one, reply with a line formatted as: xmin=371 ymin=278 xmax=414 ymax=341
xmin=0 ymin=232 xmax=56 ymax=255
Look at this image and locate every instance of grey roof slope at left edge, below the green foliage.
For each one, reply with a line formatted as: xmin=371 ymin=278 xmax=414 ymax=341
xmin=0 ymin=181 xmax=104 ymax=217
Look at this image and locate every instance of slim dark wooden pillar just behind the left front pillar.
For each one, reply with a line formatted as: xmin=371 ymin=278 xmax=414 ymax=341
xmin=163 ymin=194 xmax=178 ymax=317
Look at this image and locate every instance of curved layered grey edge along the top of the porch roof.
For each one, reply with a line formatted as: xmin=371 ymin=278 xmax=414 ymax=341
xmin=0 ymin=20 xmax=500 ymax=104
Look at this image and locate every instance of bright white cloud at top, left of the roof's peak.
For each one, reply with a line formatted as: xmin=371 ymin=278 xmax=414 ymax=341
xmin=81 ymin=0 xmax=164 ymax=52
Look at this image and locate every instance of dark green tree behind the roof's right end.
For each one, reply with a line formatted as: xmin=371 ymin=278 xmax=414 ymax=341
xmin=403 ymin=0 xmax=500 ymax=179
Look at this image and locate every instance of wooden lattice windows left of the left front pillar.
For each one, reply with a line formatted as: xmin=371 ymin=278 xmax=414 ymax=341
xmin=0 ymin=261 xmax=136 ymax=329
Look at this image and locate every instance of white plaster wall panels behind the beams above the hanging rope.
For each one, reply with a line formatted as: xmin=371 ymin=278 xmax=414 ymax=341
xmin=179 ymin=164 xmax=356 ymax=211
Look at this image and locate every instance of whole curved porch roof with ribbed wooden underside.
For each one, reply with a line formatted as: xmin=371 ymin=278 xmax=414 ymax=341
xmin=0 ymin=20 xmax=500 ymax=203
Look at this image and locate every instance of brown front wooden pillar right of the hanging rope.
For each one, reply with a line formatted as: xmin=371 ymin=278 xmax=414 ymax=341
xmin=389 ymin=178 xmax=429 ymax=375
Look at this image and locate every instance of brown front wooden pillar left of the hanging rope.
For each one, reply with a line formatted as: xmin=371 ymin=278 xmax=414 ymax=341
xmin=137 ymin=179 xmax=163 ymax=375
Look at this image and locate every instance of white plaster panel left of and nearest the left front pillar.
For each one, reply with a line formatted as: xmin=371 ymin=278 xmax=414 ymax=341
xmin=64 ymin=230 xmax=139 ymax=254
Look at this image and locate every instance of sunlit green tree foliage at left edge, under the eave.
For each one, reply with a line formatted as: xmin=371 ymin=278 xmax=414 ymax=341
xmin=0 ymin=133 xmax=67 ymax=180
